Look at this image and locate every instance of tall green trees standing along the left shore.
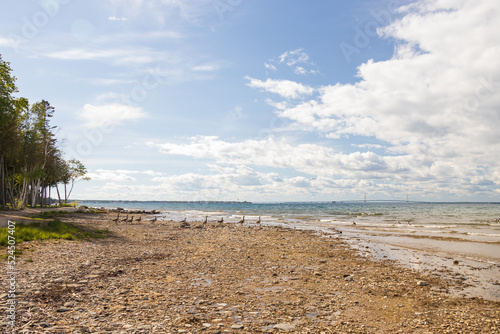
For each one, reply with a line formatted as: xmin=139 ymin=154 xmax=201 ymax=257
xmin=0 ymin=54 xmax=89 ymax=210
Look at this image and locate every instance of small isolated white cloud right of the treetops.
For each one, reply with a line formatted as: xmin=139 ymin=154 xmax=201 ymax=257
xmin=80 ymin=103 xmax=147 ymax=128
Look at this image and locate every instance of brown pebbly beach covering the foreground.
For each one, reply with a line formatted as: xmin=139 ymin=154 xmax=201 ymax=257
xmin=0 ymin=213 xmax=500 ymax=333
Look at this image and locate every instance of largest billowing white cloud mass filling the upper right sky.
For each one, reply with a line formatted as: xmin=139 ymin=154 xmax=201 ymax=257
xmin=246 ymin=0 xmax=500 ymax=196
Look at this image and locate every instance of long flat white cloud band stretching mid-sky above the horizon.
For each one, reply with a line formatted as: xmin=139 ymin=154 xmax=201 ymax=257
xmin=147 ymin=136 xmax=406 ymax=177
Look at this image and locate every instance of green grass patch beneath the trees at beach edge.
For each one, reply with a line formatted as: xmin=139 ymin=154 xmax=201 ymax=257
xmin=0 ymin=218 xmax=109 ymax=246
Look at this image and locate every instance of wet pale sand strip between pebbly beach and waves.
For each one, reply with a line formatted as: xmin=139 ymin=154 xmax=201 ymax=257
xmin=268 ymin=220 xmax=500 ymax=302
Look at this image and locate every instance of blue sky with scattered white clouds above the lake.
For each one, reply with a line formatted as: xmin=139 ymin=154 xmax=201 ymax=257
xmin=0 ymin=0 xmax=500 ymax=202
